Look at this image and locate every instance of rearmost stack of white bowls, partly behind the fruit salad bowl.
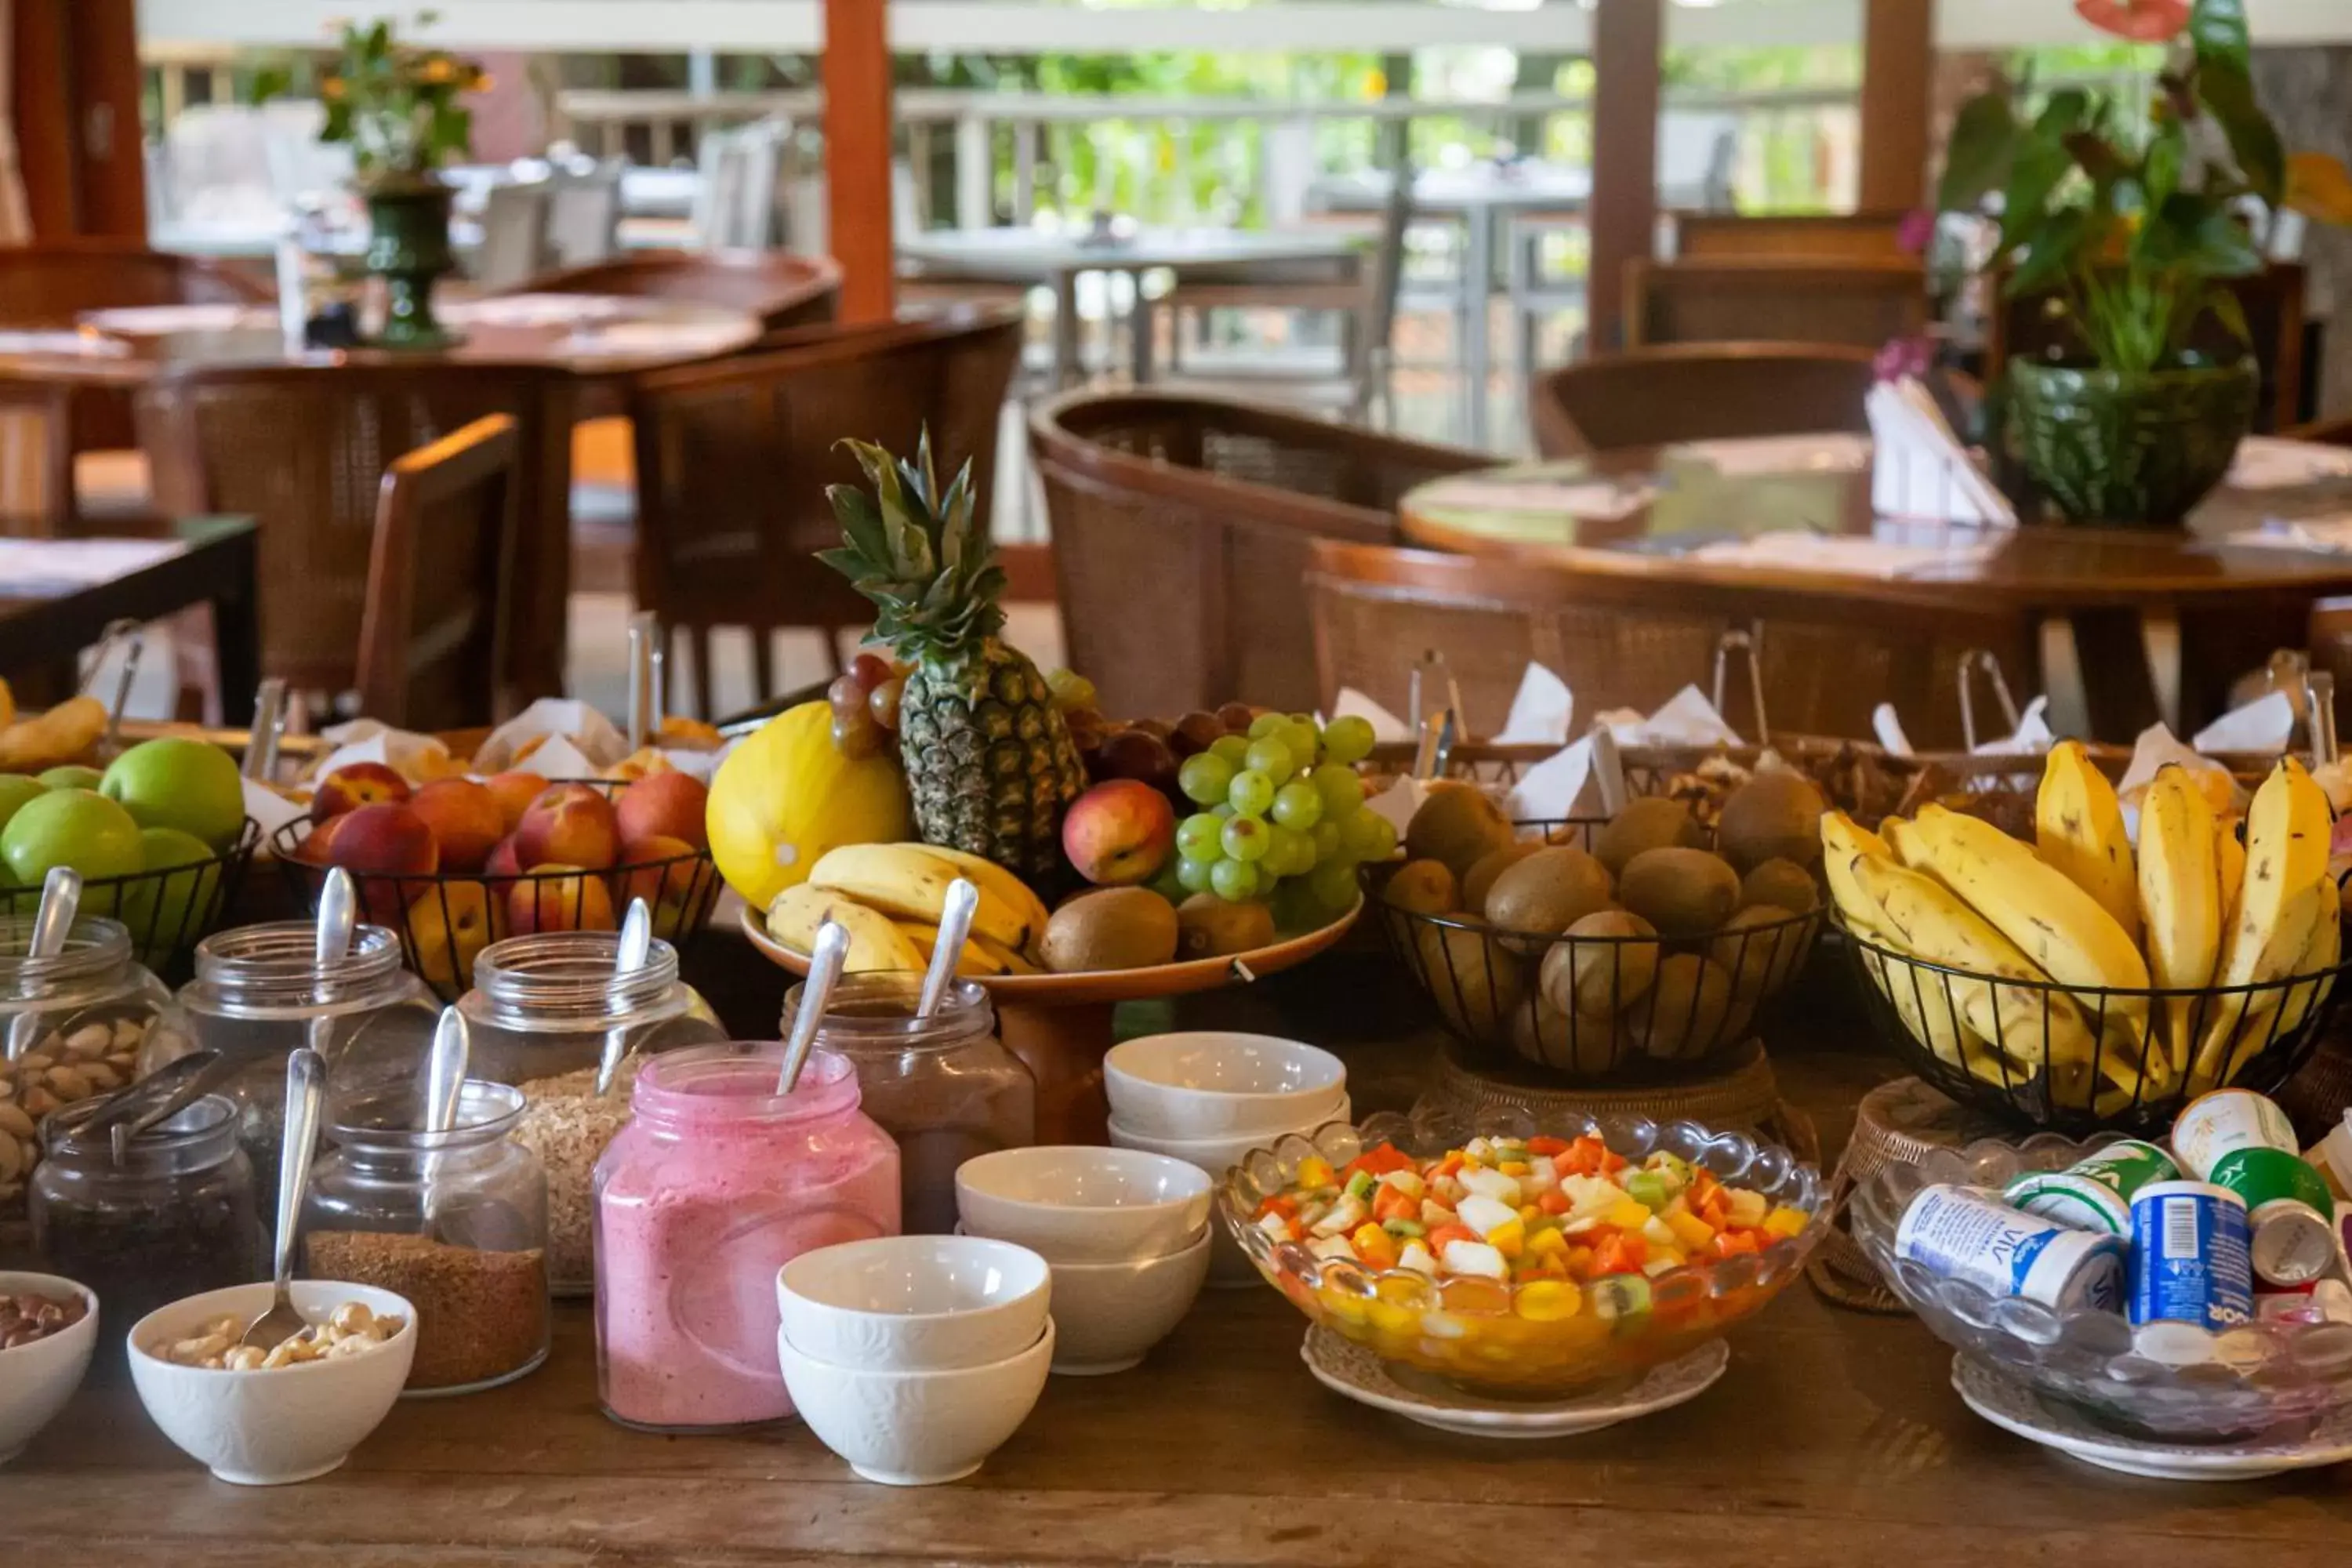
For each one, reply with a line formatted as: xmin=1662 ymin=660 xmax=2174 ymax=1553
xmin=1103 ymin=1029 xmax=1355 ymax=1286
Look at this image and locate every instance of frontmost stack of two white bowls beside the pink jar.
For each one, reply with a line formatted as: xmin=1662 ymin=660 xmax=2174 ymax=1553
xmin=776 ymin=1236 xmax=1054 ymax=1486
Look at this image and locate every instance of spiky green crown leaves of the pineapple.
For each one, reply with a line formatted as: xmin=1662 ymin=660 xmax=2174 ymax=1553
xmin=816 ymin=428 xmax=1004 ymax=659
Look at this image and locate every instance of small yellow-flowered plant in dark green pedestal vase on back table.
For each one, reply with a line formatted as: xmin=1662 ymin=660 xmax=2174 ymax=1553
xmin=254 ymin=12 xmax=489 ymax=348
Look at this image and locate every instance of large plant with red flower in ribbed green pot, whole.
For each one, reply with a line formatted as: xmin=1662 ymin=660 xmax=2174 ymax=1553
xmin=1940 ymin=0 xmax=2345 ymax=527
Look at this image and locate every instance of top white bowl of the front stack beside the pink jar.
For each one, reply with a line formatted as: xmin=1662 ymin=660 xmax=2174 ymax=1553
xmin=776 ymin=1236 xmax=1051 ymax=1370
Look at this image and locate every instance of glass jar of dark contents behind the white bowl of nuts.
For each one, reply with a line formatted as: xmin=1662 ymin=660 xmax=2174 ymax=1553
xmin=33 ymin=1095 xmax=268 ymax=1345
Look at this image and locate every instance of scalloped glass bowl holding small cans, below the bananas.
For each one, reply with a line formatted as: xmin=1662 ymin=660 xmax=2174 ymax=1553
xmin=1849 ymin=1135 xmax=2352 ymax=1441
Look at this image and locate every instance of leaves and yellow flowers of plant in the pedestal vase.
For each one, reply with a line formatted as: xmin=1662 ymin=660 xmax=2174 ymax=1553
xmin=249 ymin=12 xmax=489 ymax=188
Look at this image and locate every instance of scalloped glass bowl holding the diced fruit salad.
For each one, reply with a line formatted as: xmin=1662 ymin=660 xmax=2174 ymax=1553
xmin=1218 ymin=1107 xmax=1830 ymax=1396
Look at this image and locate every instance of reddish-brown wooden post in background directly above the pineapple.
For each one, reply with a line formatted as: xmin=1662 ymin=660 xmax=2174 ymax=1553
xmin=823 ymin=0 xmax=896 ymax=322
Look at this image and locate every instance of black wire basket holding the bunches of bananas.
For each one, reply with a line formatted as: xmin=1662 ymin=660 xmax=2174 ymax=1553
xmin=1839 ymin=921 xmax=2352 ymax=1138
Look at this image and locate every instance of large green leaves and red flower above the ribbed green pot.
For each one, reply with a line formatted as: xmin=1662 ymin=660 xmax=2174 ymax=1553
xmin=1940 ymin=0 xmax=2343 ymax=374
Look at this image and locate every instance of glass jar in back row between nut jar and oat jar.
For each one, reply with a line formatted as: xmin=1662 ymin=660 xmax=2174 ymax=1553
xmin=146 ymin=919 xmax=440 ymax=1225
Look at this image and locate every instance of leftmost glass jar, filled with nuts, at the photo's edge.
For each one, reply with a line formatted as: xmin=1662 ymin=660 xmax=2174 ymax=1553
xmin=0 ymin=914 xmax=172 ymax=1227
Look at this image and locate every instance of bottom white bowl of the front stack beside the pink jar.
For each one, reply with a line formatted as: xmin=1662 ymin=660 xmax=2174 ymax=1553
xmin=776 ymin=1319 xmax=1054 ymax=1486
